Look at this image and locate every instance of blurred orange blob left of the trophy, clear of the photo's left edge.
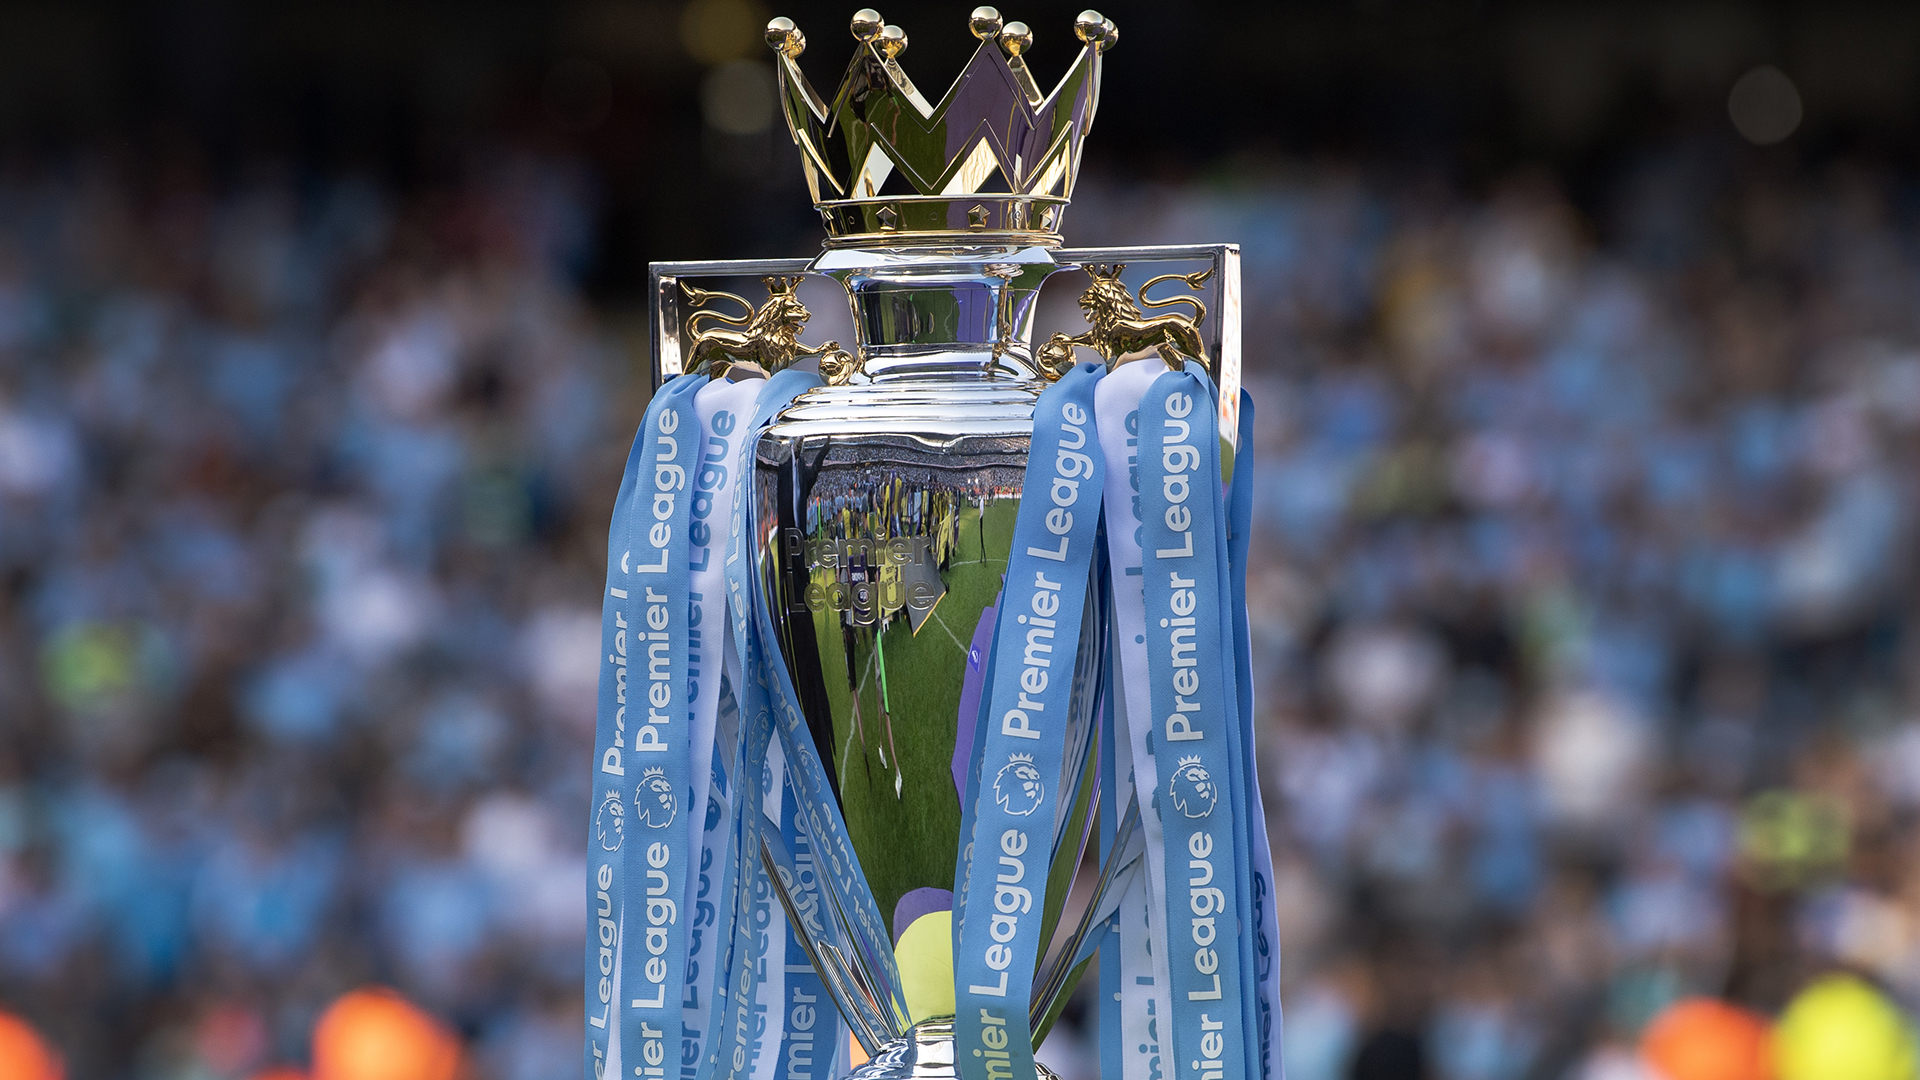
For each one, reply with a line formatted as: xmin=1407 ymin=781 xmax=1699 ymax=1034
xmin=313 ymin=988 xmax=461 ymax=1080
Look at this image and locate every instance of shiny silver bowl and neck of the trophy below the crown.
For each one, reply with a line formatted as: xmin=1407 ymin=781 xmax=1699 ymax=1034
xmin=753 ymin=244 xmax=1106 ymax=1076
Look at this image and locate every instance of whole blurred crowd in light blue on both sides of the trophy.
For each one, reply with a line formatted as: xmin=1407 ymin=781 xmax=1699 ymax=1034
xmin=11 ymin=136 xmax=1920 ymax=1080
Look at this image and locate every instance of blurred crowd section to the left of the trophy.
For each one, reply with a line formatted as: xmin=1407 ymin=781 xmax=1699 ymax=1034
xmin=0 ymin=147 xmax=622 ymax=1080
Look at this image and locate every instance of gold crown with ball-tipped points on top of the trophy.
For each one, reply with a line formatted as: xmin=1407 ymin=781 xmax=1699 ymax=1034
xmin=766 ymin=8 xmax=1119 ymax=244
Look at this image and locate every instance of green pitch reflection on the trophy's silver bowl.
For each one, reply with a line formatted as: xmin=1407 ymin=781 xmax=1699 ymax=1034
xmin=814 ymin=500 xmax=1020 ymax=930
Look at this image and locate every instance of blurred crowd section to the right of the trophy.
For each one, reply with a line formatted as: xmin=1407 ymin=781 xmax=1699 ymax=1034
xmin=1069 ymin=150 xmax=1920 ymax=1080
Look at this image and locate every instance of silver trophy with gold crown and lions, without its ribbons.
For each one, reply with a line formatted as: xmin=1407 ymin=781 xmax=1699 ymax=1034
xmin=651 ymin=8 xmax=1240 ymax=1078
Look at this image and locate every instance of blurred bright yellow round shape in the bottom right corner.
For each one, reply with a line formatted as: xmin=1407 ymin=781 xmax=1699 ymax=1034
xmin=1774 ymin=974 xmax=1914 ymax=1080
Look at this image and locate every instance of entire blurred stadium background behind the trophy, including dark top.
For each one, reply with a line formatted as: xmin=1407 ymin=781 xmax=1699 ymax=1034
xmin=0 ymin=0 xmax=1920 ymax=1080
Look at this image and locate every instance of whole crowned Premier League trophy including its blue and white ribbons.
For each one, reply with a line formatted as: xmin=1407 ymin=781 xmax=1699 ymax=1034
xmin=586 ymin=8 xmax=1279 ymax=1080
